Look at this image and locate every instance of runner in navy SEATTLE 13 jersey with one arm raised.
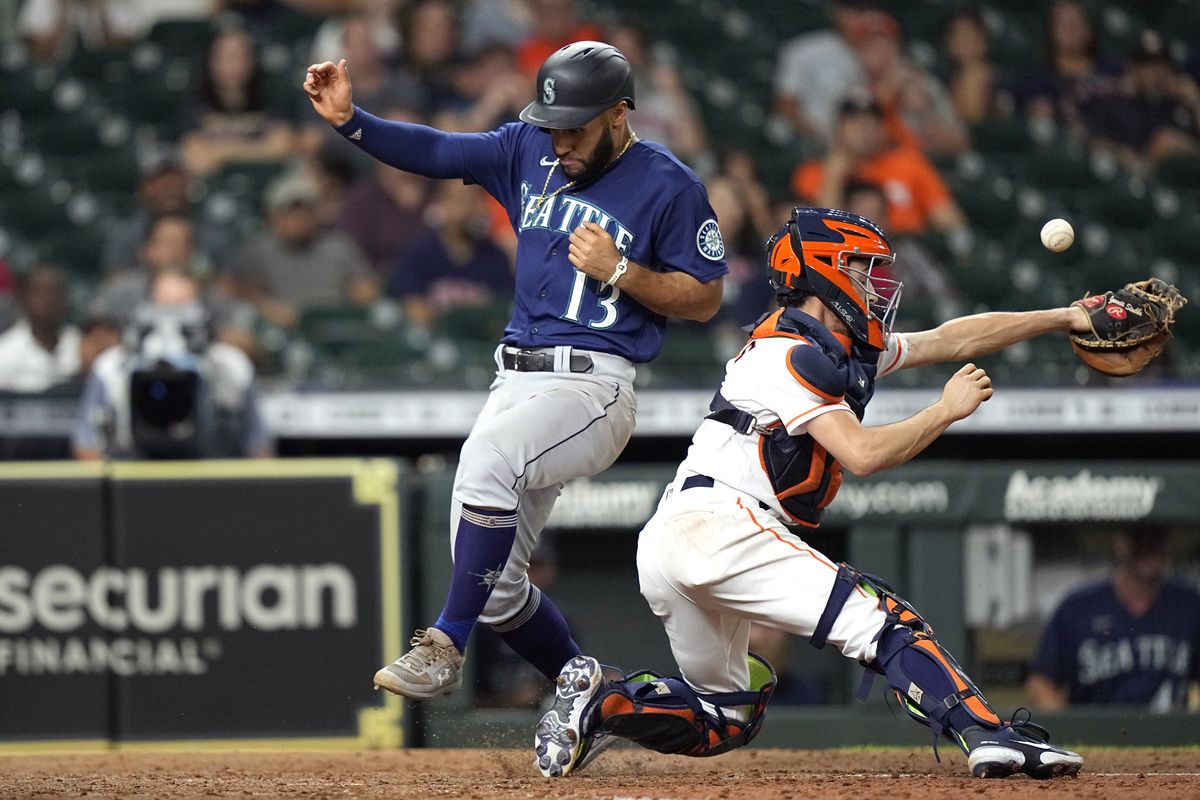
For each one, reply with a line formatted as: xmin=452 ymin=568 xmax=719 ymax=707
xmin=304 ymin=42 xmax=726 ymax=698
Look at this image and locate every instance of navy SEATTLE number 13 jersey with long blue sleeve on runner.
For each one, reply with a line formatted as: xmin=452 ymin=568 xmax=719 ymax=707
xmin=338 ymin=109 xmax=727 ymax=361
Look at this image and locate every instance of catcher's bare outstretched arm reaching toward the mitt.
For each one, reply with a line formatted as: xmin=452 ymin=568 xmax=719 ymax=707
xmin=904 ymin=306 xmax=1091 ymax=369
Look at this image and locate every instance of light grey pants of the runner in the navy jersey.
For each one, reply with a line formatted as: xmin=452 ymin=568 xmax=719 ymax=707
xmin=450 ymin=372 xmax=636 ymax=624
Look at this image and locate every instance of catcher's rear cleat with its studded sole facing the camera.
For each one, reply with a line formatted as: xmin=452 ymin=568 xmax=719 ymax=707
xmin=533 ymin=656 xmax=611 ymax=777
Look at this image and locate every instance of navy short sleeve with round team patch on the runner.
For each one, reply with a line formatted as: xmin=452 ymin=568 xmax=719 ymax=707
xmin=647 ymin=181 xmax=730 ymax=283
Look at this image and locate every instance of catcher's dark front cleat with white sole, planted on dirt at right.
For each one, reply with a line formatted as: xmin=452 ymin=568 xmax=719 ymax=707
xmin=962 ymin=715 xmax=1084 ymax=780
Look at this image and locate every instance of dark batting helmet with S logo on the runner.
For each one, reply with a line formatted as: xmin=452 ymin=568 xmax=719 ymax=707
xmin=521 ymin=42 xmax=634 ymax=130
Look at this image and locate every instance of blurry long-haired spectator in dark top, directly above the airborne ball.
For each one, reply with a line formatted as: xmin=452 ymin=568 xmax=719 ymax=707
xmin=1014 ymin=0 xmax=1120 ymax=142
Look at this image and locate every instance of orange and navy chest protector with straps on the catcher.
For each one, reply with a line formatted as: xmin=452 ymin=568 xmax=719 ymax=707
xmin=708 ymin=307 xmax=878 ymax=528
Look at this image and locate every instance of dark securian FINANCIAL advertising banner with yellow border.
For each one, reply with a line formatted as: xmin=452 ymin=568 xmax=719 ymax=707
xmin=0 ymin=459 xmax=402 ymax=750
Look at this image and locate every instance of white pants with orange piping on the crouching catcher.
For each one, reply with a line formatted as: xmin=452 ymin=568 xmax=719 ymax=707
xmin=638 ymin=488 xmax=886 ymax=692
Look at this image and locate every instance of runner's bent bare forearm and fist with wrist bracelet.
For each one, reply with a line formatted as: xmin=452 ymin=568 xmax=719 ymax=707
xmin=566 ymin=222 xmax=724 ymax=323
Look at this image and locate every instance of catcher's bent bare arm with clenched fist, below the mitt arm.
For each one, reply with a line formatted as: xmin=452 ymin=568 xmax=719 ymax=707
xmin=806 ymin=363 xmax=991 ymax=476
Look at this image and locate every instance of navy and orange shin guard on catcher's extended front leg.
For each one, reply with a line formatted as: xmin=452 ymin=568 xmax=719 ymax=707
xmin=810 ymin=564 xmax=1001 ymax=754
